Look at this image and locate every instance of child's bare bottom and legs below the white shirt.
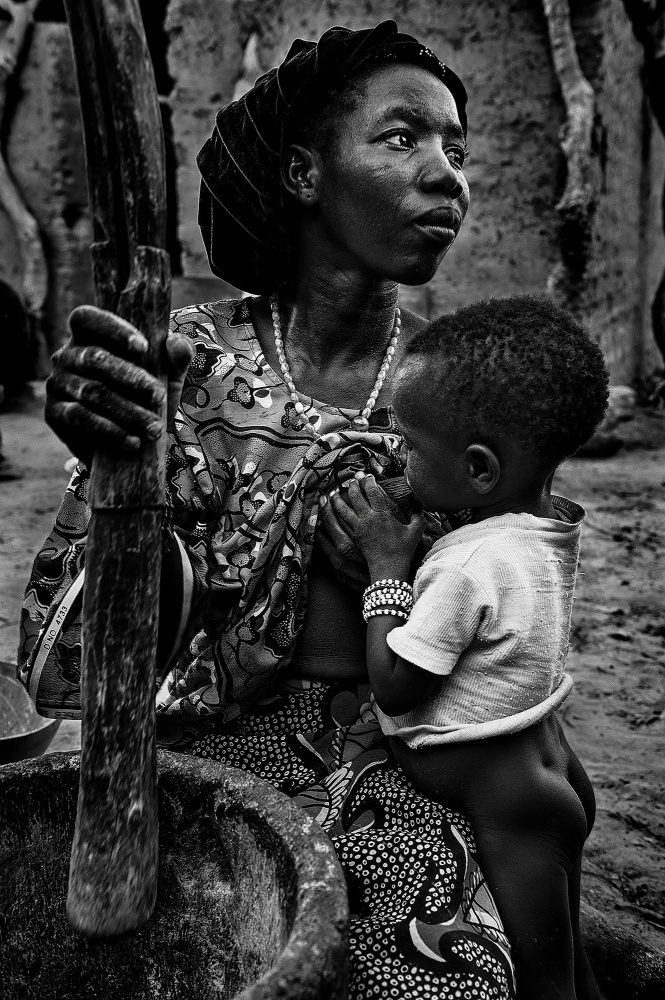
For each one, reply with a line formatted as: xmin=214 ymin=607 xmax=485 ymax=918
xmin=391 ymin=718 xmax=595 ymax=1000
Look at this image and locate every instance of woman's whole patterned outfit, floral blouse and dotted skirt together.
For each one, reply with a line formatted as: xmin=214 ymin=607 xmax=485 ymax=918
xmin=19 ymin=299 xmax=514 ymax=1000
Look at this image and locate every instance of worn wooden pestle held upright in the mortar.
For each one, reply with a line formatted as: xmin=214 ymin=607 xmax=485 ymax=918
xmin=67 ymin=252 xmax=168 ymax=937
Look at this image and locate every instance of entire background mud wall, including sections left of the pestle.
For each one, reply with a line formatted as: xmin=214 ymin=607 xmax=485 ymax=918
xmin=0 ymin=0 xmax=665 ymax=382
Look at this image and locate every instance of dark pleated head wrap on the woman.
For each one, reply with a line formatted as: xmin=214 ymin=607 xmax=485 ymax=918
xmin=197 ymin=21 xmax=467 ymax=294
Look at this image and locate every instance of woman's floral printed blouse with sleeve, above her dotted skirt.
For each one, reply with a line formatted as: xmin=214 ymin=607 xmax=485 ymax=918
xmin=18 ymin=299 xmax=402 ymax=718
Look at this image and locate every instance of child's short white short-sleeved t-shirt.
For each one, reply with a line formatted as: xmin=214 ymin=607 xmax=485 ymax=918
xmin=375 ymin=496 xmax=584 ymax=747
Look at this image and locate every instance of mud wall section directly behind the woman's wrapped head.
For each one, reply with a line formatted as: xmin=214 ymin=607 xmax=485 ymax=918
xmin=167 ymin=0 xmax=559 ymax=312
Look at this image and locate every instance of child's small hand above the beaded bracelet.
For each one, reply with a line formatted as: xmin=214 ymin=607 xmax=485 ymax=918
xmin=330 ymin=472 xmax=425 ymax=580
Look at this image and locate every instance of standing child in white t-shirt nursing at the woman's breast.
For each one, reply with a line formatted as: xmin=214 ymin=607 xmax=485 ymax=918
xmin=332 ymin=297 xmax=608 ymax=1000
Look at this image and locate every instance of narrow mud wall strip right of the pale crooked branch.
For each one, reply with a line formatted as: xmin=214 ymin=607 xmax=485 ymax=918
xmin=572 ymin=0 xmax=665 ymax=382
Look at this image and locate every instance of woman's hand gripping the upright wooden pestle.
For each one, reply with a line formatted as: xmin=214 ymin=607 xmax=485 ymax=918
xmin=45 ymin=306 xmax=193 ymax=464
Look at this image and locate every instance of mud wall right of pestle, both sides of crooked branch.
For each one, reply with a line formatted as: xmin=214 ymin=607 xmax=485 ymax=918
xmin=167 ymin=0 xmax=664 ymax=382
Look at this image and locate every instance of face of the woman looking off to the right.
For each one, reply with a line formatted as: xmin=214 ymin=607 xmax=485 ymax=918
xmin=317 ymin=65 xmax=469 ymax=284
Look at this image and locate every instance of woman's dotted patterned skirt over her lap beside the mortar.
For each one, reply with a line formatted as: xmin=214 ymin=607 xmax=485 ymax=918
xmin=158 ymin=681 xmax=514 ymax=1000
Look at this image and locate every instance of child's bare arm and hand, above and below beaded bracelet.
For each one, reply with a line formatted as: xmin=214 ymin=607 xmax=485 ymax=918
xmin=332 ymin=476 xmax=440 ymax=715
